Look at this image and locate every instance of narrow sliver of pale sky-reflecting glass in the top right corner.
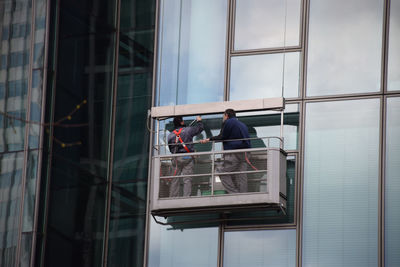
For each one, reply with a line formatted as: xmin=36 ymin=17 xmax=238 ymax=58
xmin=388 ymin=1 xmax=400 ymax=90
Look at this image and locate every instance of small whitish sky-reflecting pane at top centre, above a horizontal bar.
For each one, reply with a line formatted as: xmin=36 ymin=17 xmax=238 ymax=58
xmin=234 ymin=0 xmax=301 ymax=50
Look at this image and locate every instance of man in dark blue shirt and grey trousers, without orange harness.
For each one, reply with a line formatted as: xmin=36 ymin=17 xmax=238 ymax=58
xmin=200 ymin=109 xmax=251 ymax=194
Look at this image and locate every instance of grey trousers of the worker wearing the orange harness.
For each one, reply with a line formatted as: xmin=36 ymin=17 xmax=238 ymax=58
xmin=169 ymin=156 xmax=194 ymax=197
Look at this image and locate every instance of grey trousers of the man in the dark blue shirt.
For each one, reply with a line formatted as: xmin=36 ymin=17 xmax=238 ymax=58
xmin=220 ymin=153 xmax=247 ymax=194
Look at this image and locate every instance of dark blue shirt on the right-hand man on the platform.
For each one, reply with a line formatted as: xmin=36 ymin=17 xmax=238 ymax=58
xmin=222 ymin=118 xmax=251 ymax=150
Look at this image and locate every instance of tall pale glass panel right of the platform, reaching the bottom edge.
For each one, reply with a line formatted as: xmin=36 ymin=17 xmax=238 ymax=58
xmin=303 ymin=99 xmax=380 ymax=267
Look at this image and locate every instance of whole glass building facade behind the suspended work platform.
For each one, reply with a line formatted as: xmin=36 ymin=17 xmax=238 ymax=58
xmin=0 ymin=0 xmax=400 ymax=267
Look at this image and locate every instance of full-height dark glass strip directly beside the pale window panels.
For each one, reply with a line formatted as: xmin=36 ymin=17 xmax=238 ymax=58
xmin=107 ymin=0 xmax=155 ymax=267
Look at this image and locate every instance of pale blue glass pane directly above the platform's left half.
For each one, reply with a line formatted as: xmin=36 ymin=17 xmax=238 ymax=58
xmin=156 ymin=0 xmax=227 ymax=106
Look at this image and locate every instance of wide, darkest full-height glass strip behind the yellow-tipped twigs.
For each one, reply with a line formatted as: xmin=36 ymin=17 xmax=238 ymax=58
xmin=44 ymin=0 xmax=116 ymax=266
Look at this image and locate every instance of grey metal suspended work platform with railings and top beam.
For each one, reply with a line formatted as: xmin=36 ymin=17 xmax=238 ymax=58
xmin=150 ymin=98 xmax=287 ymax=223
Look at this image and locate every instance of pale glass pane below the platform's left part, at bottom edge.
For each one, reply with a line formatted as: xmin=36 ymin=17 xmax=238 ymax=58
xmin=149 ymin=220 xmax=218 ymax=267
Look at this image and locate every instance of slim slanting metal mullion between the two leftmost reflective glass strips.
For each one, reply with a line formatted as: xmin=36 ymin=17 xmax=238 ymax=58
xmin=15 ymin=0 xmax=36 ymax=267
